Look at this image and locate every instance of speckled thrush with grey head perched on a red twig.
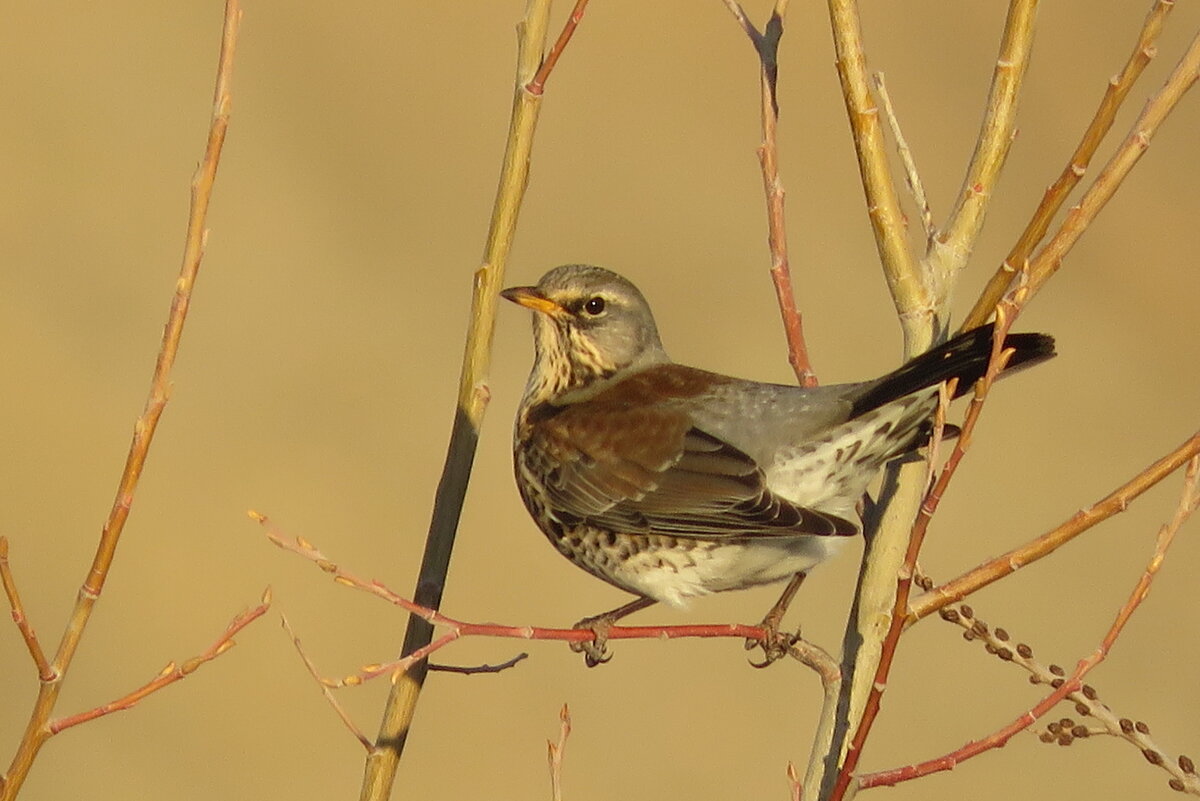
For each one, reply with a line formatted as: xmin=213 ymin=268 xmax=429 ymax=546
xmin=500 ymin=264 xmax=1055 ymax=667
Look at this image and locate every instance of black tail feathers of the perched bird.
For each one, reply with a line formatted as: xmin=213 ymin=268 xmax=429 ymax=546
xmin=850 ymin=323 xmax=1055 ymax=417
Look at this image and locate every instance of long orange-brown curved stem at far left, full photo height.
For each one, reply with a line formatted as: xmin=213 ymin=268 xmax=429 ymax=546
xmin=0 ymin=0 xmax=241 ymax=801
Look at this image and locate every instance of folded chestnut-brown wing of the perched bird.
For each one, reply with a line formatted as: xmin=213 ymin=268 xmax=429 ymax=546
xmin=526 ymin=401 xmax=858 ymax=540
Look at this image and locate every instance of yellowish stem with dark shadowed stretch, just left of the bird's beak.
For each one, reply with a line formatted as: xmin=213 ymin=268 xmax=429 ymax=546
xmin=360 ymin=0 xmax=566 ymax=800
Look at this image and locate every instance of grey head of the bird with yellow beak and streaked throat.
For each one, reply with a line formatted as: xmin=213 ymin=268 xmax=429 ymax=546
xmin=500 ymin=264 xmax=670 ymax=402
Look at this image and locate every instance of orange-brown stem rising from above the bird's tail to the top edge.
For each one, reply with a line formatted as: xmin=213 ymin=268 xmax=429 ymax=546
xmin=962 ymin=0 xmax=1175 ymax=331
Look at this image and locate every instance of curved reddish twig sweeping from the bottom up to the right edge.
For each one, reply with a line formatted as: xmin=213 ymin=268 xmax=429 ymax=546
xmin=858 ymin=457 xmax=1200 ymax=789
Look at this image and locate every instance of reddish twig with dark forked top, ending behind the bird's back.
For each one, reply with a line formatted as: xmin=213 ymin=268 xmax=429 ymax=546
xmin=725 ymin=0 xmax=817 ymax=386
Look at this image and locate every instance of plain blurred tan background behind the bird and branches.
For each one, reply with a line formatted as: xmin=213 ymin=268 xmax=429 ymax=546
xmin=0 ymin=0 xmax=1200 ymax=801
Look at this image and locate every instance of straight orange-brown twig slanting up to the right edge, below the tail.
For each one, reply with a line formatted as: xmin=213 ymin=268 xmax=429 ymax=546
xmin=905 ymin=432 xmax=1200 ymax=626
